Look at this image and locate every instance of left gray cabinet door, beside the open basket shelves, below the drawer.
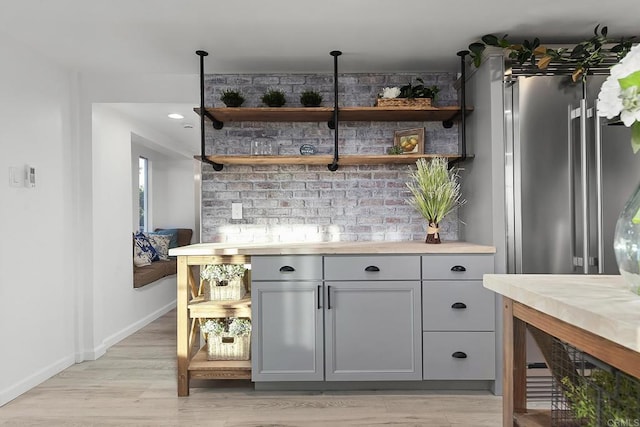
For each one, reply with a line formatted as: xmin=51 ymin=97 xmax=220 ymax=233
xmin=251 ymin=282 xmax=324 ymax=381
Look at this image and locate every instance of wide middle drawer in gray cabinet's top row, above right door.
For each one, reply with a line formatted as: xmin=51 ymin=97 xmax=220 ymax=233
xmin=324 ymin=255 xmax=420 ymax=280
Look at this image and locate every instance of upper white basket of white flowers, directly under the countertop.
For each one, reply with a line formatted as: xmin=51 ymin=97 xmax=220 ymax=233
xmin=200 ymin=264 xmax=247 ymax=301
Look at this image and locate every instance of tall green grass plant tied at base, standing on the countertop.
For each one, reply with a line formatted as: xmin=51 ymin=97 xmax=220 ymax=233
xmin=407 ymin=157 xmax=466 ymax=243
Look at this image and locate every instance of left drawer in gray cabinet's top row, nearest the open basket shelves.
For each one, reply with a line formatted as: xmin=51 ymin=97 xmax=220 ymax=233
xmin=251 ymin=255 xmax=322 ymax=281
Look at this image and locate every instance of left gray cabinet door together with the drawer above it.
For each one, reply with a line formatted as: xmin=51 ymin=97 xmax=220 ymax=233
xmin=251 ymin=255 xmax=324 ymax=381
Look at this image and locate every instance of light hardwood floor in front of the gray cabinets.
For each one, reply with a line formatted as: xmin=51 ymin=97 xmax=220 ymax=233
xmin=0 ymin=311 xmax=502 ymax=427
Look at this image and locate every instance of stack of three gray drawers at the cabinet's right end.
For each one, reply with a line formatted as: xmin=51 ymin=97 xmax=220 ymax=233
xmin=422 ymin=254 xmax=496 ymax=380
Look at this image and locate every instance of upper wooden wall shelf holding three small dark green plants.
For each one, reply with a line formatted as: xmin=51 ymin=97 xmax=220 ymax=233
xmin=194 ymin=106 xmax=472 ymax=123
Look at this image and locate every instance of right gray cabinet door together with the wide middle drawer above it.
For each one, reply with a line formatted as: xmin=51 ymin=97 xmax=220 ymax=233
xmin=324 ymin=255 xmax=422 ymax=381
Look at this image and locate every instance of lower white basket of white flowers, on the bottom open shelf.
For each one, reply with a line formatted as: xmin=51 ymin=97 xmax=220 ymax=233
xmin=200 ymin=317 xmax=251 ymax=360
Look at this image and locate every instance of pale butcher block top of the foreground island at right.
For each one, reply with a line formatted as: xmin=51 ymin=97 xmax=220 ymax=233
xmin=484 ymin=274 xmax=640 ymax=352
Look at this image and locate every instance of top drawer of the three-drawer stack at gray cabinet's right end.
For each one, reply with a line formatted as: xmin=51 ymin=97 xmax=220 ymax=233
xmin=422 ymin=254 xmax=493 ymax=280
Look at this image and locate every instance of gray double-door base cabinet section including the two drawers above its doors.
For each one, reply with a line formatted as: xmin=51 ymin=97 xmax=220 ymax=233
xmin=251 ymin=256 xmax=422 ymax=381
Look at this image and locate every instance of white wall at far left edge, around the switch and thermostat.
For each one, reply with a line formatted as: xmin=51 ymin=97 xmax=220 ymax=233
xmin=0 ymin=36 xmax=81 ymax=405
